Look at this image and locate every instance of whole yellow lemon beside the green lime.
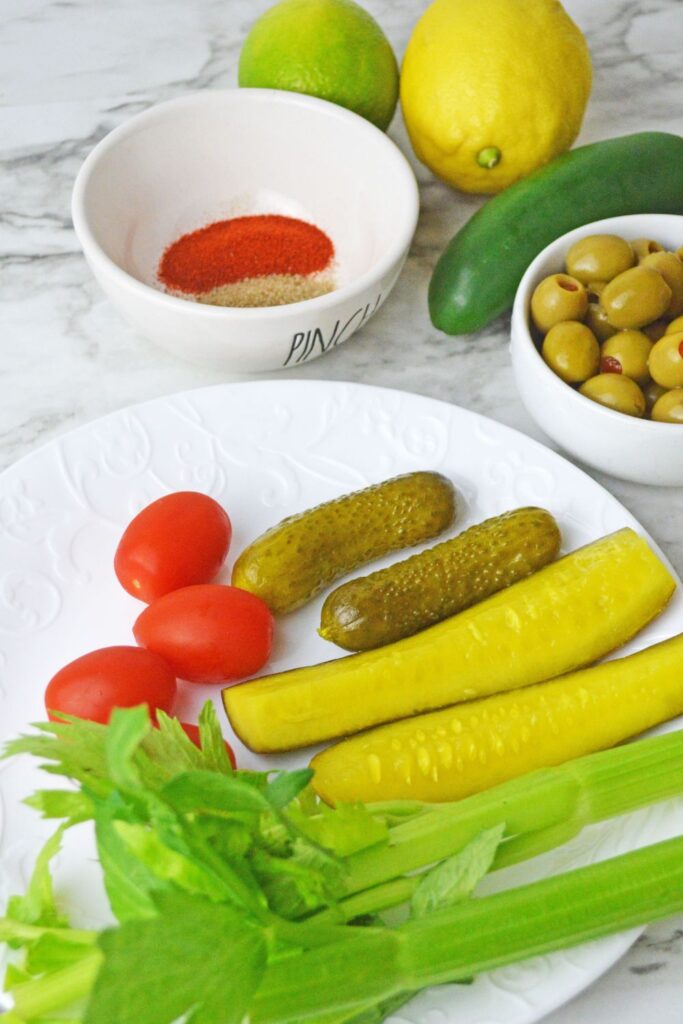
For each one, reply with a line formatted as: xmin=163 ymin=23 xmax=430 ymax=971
xmin=400 ymin=0 xmax=592 ymax=193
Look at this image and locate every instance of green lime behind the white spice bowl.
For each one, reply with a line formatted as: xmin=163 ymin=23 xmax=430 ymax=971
xmin=239 ymin=0 xmax=398 ymax=129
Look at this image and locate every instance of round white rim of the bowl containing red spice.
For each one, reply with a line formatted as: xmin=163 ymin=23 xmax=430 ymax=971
xmin=71 ymin=88 xmax=420 ymax=321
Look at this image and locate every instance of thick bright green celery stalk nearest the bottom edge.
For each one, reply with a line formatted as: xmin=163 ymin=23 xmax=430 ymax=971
xmin=250 ymin=837 xmax=683 ymax=1024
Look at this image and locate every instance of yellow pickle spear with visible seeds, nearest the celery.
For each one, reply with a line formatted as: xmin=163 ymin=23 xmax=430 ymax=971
xmin=311 ymin=634 xmax=683 ymax=803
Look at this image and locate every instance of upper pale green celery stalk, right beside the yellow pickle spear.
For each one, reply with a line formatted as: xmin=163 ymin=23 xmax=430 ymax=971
xmin=346 ymin=732 xmax=683 ymax=897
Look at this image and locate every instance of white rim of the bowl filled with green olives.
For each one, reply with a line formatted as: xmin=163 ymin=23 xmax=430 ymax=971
xmin=511 ymin=213 xmax=683 ymax=439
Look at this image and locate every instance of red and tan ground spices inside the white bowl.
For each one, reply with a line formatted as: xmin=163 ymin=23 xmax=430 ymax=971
xmin=158 ymin=207 xmax=335 ymax=306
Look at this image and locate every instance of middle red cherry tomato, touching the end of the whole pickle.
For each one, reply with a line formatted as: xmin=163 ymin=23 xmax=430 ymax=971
xmin=133 ymin=584 xmax=272 ymax=683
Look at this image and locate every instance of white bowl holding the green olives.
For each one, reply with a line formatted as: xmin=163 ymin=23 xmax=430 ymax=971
xmin=511 ymin=213 xmax=683 ymax=486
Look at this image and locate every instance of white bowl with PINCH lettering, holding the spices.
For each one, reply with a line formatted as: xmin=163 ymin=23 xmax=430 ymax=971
xmin=72 ymin=89 xmax=419 ymax=372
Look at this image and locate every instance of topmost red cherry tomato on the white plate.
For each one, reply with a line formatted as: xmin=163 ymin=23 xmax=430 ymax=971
xmin=114 ymin=490 xmax=232 ymax=602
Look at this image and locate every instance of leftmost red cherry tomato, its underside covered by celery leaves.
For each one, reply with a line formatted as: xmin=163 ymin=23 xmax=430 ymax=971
xmin=45 ymin=647 xmax=176 ymax=724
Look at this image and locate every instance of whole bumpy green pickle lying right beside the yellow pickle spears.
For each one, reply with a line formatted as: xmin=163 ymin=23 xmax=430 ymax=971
xmin=319 ymin=508 xmax=560 ymax=650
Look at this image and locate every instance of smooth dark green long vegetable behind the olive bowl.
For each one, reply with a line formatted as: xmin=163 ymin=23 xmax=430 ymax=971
xmin=429 ymin=132 xmax=683 ymax=334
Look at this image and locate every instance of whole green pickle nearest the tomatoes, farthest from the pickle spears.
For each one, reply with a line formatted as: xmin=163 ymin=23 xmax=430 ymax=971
xmin=232 ymin=472 xmax=456 ymax=613
